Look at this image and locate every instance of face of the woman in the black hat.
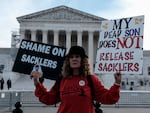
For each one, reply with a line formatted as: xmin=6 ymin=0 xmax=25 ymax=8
xmin=69 ymin=55 xmax=81 ymax=69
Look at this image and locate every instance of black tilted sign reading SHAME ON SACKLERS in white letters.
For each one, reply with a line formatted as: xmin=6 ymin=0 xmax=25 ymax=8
xmin=12 ymin=40 xmax=66 ymax=80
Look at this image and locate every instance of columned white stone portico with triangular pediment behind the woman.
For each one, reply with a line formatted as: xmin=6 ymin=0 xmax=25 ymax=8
xmin=17 ymin=6 xmax=105 ymax=69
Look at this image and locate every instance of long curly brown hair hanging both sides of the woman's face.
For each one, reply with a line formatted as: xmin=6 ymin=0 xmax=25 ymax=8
xmin=62 ymin=57 xmax=92 ymax=77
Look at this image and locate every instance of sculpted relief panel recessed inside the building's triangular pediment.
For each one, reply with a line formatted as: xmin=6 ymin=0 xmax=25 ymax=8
xmin=22 ymin=9 xmax=100 ymax=22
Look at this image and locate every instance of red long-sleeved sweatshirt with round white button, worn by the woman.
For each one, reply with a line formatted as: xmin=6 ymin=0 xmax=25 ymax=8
xmin=35 ymin=75 xmax=120 ymax=113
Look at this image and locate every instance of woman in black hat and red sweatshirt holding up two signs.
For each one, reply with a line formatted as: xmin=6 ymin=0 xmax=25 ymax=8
xmin=31 ymin=46 xmax=121 ymax=113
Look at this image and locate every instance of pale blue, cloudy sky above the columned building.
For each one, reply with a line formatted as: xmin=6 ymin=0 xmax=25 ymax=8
xmin=0 ymin=0 xmax=150 ymax=50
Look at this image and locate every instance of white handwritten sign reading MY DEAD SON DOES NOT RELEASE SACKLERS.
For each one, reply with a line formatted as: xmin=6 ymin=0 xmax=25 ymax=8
xmin=94 ymin=16 xmax=144 ymax=74
